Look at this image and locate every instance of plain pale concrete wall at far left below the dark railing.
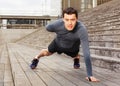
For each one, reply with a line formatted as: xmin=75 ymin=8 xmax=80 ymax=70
xmin=0 ymin=29 xmax=36 ymax=44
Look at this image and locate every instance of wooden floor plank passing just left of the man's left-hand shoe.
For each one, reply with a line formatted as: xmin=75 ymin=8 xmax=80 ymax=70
xmin=7 ymin=43 xmax=46 ymax=86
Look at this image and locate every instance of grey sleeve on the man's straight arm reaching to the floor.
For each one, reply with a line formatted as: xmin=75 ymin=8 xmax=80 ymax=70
xmin=80 ymin=25 xmax=92 ymax=76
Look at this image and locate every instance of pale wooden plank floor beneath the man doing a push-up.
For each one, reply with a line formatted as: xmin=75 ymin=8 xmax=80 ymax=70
xmin=0 ymin=43 xmax=120 ymax=86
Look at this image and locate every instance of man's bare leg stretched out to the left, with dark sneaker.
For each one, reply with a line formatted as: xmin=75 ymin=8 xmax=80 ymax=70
xmin=30 ymin=49 xmax=52 ymax=69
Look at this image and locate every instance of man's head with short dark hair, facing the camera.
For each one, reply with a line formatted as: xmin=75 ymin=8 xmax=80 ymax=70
xmin=62 ymin=7 xmax=78 ymax=31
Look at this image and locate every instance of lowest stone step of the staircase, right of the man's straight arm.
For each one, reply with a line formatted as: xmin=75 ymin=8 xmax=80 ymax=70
xmin=80 ymin=53 xmax=120 ymax=72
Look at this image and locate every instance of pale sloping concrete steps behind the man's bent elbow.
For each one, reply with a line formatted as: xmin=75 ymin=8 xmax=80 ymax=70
xmin=16 ymin=27 xmax=55 ymax=49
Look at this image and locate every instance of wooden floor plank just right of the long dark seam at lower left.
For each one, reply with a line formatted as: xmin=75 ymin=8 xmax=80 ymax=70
xmin=8 ymin=45 xmax=31 ymax=86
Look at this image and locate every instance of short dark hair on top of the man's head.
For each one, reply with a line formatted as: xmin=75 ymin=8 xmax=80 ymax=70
xmin=62 ymin=7 xmax=78 ymax=18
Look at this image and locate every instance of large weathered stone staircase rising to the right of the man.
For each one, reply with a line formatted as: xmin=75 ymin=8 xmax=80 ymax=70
xmin=79 ymin=0 xmax=120 ymax=71
